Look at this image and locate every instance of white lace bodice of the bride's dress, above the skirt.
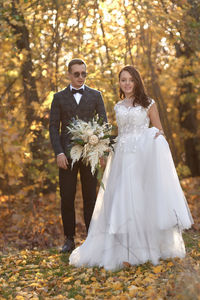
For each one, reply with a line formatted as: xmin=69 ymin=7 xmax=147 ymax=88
xmin=114 ymin=99 xmax=155 ymax=152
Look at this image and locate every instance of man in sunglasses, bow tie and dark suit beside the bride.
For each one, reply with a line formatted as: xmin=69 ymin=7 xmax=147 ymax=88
xmin=49 ymin=59 xmax=107 ymax=253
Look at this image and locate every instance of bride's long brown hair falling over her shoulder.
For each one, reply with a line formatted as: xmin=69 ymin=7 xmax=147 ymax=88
xmin=119 ymin=66 xmax=151 ymax=108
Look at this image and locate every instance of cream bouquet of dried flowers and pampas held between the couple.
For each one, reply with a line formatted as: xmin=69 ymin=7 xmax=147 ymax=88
xmin=67 ymin=115 xmax=113 ymax=174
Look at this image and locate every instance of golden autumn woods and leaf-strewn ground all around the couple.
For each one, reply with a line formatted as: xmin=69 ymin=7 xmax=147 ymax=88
xmin=0 ymin=0 xmax=200 ymax=300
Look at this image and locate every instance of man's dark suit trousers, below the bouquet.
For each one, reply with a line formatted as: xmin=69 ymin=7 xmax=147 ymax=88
xmin=59 ymin=161 xmax=97 ymax=237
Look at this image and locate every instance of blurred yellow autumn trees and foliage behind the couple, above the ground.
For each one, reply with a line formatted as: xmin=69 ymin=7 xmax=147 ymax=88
xmin=0 ymin=0 xmax=200 ymax=200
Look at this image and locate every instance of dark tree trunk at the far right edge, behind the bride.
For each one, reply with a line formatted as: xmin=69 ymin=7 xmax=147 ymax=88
xmin=174 ymin=0 xmax=200 ymax=176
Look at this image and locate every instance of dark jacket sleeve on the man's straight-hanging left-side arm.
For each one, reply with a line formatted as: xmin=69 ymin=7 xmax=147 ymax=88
xmin=49 ymin=94 xmax=64 ymax=156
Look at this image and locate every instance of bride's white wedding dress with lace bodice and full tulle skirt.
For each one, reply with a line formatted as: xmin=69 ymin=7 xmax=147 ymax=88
xmin=69 ymin=100 xmax=193 ymax=270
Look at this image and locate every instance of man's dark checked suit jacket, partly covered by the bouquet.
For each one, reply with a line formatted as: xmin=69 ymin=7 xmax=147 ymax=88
xmin=49 ymin=85 xmax=107 ymax=156
